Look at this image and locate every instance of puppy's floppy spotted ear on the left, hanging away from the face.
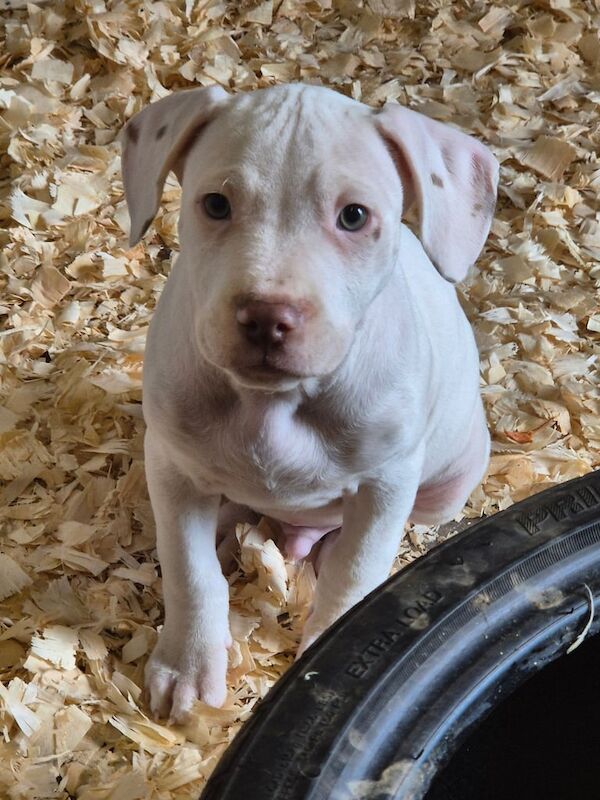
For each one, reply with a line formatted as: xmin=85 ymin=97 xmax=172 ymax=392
xmin=119 ymin=86 xmax=229 ymax=247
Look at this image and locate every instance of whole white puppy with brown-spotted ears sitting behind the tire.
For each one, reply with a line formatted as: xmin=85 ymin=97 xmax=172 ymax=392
xmin=123 ymin=84 xmax=498 ymax=721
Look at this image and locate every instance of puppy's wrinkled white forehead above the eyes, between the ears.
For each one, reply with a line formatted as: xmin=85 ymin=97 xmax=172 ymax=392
xmin=186 ymin=87 xmax=395 ymax=197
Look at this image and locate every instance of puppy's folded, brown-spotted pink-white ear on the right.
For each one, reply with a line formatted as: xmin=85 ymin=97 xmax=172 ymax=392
xmin=374 ymin=103 xmax=498 ymax=282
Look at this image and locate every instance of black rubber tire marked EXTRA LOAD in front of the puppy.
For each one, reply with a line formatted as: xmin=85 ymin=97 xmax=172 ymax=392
xmin=201 ymin=471 xmax=600 ymax=800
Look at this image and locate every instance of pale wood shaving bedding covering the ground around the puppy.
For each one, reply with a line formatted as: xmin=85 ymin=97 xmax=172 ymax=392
xmin=0 ymin=0 xmax=600 ymax=800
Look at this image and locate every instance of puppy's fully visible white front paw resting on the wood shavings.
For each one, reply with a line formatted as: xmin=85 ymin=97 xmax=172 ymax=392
xmin=145 ymin=629 xmax=231 ymax=725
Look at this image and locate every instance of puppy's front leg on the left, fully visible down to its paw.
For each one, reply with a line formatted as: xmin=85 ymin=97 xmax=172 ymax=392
xmin=145 ymin=432 xmax=231 ymax=722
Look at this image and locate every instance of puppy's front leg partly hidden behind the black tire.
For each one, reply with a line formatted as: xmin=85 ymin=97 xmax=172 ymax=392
xmin=298 ymin=456 xmax=422 ymax=656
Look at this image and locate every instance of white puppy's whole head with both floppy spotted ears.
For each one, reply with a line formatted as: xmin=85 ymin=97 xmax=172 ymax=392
xmin=123 ymin=84 xmax=495 ymax=391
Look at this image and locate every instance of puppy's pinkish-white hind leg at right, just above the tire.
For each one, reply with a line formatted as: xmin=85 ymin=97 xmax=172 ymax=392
xmin=409 ymin=405 xmax=490 ymax=525
